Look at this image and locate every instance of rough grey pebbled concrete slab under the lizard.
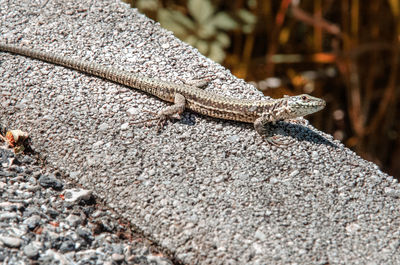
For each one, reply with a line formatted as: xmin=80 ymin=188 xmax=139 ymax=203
xmin=0 ymin=0 xmax=400 ymax=264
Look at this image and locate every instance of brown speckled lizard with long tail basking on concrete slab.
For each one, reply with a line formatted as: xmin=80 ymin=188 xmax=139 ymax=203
xmin=0 ymin=42 xmax=326 ymax=144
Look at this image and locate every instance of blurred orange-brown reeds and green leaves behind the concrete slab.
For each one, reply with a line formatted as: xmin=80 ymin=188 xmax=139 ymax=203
xmin=126 ymin=0 xmax=400 ymax=178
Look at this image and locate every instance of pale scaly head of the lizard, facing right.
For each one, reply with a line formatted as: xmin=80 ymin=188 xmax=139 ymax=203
xmin=282 ymin=94 xmax=326 ymax=119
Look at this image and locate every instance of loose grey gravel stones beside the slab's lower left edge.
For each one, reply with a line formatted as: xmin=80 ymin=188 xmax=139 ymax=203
xmin=0 ymin=147 xmax=173 ymax=264
